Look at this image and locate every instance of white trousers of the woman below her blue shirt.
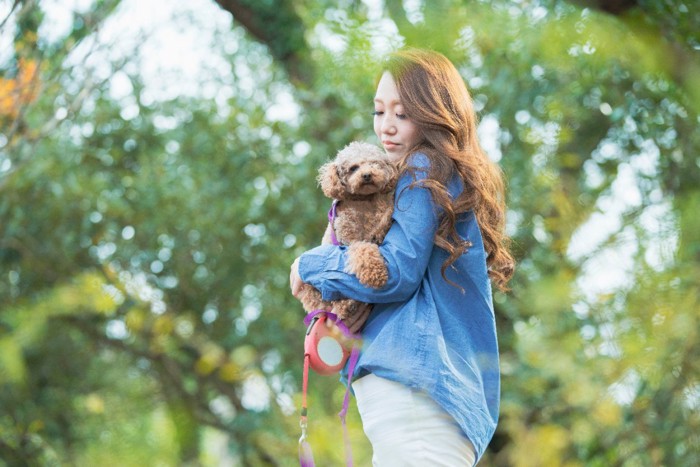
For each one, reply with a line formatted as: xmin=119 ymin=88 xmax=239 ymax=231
xmin=352 ymin=374 xmax=475 ymax=467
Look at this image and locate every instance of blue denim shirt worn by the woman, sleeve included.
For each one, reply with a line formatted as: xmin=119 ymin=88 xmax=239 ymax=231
xmin=299 ymin=154 xmax=500 ymax=459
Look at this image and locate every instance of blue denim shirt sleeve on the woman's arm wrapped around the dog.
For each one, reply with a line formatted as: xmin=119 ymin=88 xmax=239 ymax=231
xmin=299 ymin=159 xmax=438 ymax=303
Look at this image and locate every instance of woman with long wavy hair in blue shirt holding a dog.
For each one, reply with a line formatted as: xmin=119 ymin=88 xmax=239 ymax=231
xmin=290 ymin=49 xmax=514 ymax=467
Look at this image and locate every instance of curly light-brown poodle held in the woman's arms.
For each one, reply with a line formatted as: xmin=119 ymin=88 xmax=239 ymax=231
xmin=298 ymin=141 xmax=398 ymax=319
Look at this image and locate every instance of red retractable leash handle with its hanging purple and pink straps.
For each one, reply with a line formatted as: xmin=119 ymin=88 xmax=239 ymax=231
xmin=299 ymin=310 xmax=360 ymax=467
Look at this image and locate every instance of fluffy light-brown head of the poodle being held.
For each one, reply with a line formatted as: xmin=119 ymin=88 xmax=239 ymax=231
xmin=318 ymin=141 xmax=398 ymax=200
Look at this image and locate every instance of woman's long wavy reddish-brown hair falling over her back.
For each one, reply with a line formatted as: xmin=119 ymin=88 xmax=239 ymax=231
xmin=382 ymin=49 xmax=515 ymax=290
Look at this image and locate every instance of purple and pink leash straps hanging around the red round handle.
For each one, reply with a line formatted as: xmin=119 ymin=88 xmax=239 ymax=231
xmin=299 ymin=310 xmax=360 ymax=467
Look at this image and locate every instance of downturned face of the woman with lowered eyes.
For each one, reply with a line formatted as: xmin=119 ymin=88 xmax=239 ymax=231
xmin=374 ymin=72 xmax=420 ymax=161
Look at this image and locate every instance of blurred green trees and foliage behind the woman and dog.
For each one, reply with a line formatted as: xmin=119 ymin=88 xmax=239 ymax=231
xmin=0 ymin=0 xmax=700 ymax=466
